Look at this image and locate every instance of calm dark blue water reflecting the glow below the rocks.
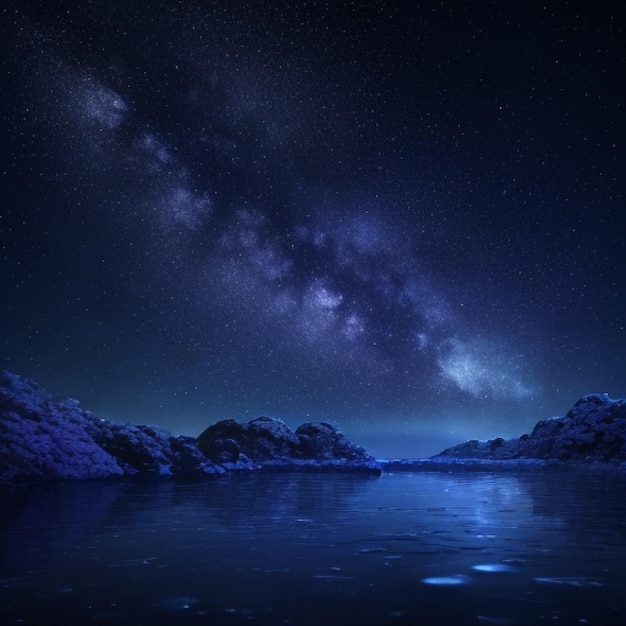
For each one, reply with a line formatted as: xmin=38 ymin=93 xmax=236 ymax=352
xmin=0 ymin=471 xmax=626 ymax=626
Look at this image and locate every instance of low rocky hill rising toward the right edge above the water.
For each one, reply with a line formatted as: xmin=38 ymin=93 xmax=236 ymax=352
xmin=433 ymin=394 xmax=626 ymax=465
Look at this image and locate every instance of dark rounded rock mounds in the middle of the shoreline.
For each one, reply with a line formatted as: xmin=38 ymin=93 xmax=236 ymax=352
xmin=198 ymin=417 xmax=380 ymax=472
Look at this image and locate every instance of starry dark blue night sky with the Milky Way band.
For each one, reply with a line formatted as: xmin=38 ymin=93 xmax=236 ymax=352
xmin=0 ymin=0 xmax=626 ymax=457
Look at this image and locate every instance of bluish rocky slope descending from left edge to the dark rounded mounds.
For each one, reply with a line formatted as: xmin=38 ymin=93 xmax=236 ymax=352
xmin=0 ymin=372 xmax=224 ymax=482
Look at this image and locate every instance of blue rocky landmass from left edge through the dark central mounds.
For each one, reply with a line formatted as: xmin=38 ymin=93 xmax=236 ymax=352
xmin=0 ymin=371 xmax=381 ymax=483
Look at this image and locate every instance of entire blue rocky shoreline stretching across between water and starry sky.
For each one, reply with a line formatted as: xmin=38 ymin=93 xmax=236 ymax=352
xmin=0 ymin=371 xmax=626 ymax=484
